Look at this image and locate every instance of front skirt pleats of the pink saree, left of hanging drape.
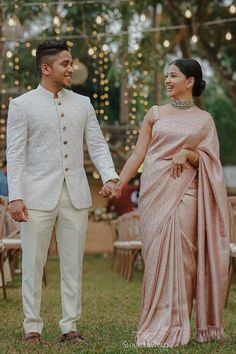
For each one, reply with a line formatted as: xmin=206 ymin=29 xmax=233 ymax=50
xmin=137 ymin=181 xmax=197 ymax=346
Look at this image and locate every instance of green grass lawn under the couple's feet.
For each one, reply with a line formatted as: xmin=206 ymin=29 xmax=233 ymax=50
xmin=0 ymin=256 xmax=236 ymax=354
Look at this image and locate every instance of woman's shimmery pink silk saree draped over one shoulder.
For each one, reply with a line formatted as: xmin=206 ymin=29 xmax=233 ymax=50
xmin=136 ymin=106 xmax=229 ymax=347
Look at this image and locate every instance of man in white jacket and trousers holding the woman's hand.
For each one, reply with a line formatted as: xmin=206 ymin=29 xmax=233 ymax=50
xmin=7 ymin=41 xmax=120 ymax=342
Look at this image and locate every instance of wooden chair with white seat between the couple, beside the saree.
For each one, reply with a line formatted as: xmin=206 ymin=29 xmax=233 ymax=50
xmin=111 ymin=211 xmax=142 ymax=281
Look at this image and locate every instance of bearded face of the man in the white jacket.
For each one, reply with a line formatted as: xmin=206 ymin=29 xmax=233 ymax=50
xmin=42 ymin=50 xmax=73 ymax=89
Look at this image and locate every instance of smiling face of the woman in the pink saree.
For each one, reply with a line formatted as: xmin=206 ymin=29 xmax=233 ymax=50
xmin=165 ymin=64 xmax=194 ymax=99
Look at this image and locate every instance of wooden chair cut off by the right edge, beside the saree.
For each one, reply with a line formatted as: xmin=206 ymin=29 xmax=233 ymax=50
xmin=225 ymin=196 xmax=236 ymax=307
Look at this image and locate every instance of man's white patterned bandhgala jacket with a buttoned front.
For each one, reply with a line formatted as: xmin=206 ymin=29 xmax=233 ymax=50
xmin=7 ymin=85 xmax=117 ymax=210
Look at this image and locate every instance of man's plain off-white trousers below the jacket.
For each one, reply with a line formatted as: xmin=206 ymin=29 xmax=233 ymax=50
xmin=21 ymin=182 xmax=88 ymax=333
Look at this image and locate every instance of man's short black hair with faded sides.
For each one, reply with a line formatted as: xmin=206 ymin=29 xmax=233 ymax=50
xmin=36 ymin=40 xmax=69 ymax=77
